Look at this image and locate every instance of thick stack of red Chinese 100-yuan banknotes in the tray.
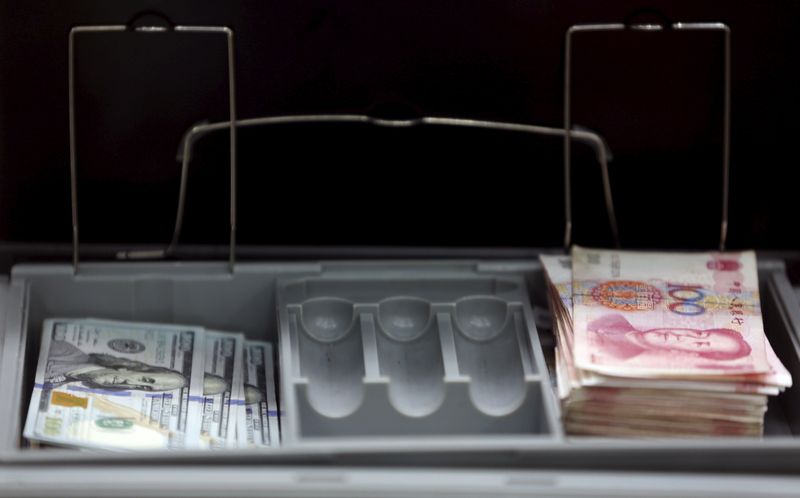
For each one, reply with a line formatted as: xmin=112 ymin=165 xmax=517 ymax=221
xmin=541 ymin=247 xmax=792 ymax=437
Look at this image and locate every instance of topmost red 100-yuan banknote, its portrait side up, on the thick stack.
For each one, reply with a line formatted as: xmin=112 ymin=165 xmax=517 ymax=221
xmin=573 ymin=247 xmax=770 ymax=377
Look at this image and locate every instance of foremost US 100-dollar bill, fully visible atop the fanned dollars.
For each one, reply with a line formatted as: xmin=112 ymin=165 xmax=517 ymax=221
xmin=24 ymin=319 xmax=205 ymax=449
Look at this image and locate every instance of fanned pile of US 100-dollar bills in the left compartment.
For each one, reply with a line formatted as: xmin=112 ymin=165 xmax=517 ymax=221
xmin=24 ymin=319 xmax=280 ymax=450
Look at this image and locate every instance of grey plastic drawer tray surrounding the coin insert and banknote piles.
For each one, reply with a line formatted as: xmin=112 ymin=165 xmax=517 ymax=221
xmin=2 ymin=260 xmax=800 ymax=473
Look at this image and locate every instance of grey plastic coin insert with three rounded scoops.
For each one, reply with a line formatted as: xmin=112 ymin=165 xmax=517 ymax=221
xmin=278 ymin=266 xmax=561 ymax=445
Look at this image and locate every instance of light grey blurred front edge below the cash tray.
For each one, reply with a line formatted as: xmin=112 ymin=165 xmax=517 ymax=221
xmin=0 ymin=465 xmax=800 ymax=498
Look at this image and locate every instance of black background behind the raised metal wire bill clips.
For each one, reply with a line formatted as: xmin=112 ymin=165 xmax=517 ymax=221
xmin=0 ymin=0 xmax=800 ymax=249
